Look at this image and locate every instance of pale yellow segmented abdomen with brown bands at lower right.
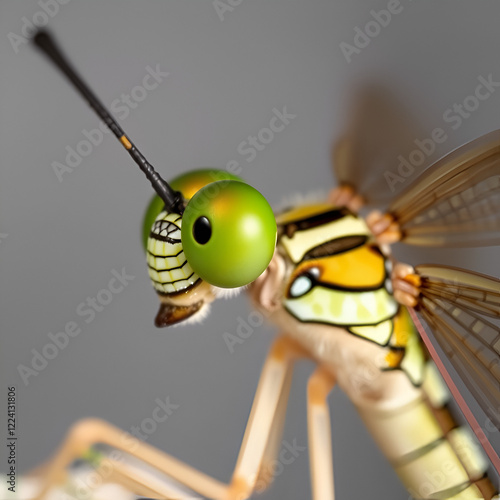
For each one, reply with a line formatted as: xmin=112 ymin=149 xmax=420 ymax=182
xmin=361 ymin=361 xmax=498 ymax=500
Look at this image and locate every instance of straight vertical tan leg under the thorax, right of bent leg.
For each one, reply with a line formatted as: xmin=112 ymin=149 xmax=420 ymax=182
xmin=307 ymin=368 xmax=335 ymax=500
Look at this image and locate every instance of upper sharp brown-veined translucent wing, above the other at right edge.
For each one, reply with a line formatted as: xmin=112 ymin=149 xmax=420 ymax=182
xmin=389 ymin=130 xmax=500 ymax=246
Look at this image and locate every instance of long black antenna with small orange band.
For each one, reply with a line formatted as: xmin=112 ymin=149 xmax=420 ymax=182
xmin=33 ymin=30 xmax=184 ymax=214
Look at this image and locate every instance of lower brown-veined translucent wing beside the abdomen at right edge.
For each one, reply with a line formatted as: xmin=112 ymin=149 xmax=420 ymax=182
xmin=416 ymin=265 xmax=500 ymax=429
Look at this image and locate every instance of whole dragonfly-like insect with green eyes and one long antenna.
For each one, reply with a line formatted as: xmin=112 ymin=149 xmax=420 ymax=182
xmin=15 ymin=33 xmax=500 ymax=500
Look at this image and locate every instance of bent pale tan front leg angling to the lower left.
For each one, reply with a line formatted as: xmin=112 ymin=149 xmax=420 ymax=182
xmin=32 ymin=338 xmax=304 ymax=500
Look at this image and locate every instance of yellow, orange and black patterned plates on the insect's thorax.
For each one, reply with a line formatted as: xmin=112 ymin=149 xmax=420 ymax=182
xmin=277 ymin=204 xmax=423 ymax=383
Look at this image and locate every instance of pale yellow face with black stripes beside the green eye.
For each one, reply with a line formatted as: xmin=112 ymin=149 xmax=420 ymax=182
xmin=147 ymin=211 xmax=200 ymax=296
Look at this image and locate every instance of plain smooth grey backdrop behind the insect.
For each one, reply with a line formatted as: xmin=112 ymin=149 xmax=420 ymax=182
xmin=0 ymin=0 xmax=500 ymax=499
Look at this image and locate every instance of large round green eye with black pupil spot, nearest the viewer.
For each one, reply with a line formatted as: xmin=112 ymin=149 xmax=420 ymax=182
xmin=181 ymin=180 xmax=276 ymax=288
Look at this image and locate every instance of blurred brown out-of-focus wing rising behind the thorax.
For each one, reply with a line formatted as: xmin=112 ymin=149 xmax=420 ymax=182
xmin=332 ymin=85 xmax=424 ymax=206
